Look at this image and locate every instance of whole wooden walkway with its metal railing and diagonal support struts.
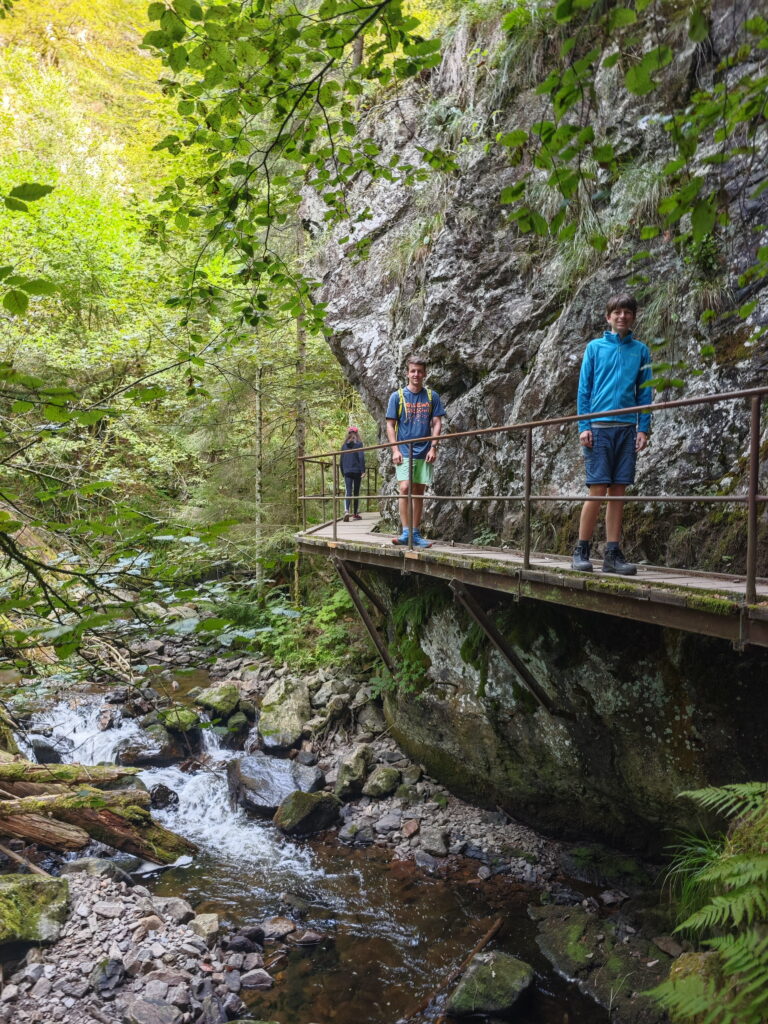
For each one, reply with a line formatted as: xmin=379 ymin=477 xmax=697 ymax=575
xmin=298 ymin=387 xmax=768 ymax=655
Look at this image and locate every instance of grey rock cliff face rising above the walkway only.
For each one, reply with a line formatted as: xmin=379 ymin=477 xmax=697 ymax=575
xmin=315 ymin=0 xmax=768 ymax=569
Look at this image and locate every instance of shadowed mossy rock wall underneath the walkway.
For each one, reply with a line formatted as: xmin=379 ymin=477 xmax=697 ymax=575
xmin=369 ymin=570 xmax=768 ymax=852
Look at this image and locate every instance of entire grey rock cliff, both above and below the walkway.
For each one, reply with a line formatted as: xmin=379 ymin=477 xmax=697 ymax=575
xmin=315 ymin=6 xmax=768 ymax=849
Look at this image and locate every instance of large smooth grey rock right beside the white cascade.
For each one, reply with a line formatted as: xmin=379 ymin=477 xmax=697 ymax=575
xmin=226 ymin=751 xmax=325 ymax=817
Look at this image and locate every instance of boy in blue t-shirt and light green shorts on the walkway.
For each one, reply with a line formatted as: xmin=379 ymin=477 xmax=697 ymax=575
xmin=386 ymin=355 xmax=445 ymax=548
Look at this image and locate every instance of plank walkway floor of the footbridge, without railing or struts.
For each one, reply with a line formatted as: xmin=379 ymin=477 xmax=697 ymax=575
xmin=298 ymin=513 xmax=768 ymax=647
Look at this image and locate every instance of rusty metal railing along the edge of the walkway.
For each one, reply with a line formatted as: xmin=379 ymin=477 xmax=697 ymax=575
xmin=300 ymin=387 xmax=768 ymax=604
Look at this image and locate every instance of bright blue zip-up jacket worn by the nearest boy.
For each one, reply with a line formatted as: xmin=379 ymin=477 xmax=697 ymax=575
xmin=577 ymin=331 xmax=653 ymax=434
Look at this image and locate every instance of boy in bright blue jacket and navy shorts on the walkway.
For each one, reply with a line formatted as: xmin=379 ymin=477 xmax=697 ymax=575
xmin=570 ymin=295 xmax=653 ymax=575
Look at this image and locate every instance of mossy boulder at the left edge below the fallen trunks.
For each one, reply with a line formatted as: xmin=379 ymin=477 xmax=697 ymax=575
xmin=0 ymin=874 xmax=70 ymax=945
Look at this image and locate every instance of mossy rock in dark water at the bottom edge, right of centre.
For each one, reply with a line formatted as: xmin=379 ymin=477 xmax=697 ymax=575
xmin=447 ymin=951 xmax=534 ymax=1017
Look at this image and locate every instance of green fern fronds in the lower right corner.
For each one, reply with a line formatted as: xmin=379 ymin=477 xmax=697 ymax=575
xmin=653 ymin=782 xmax=768 ymax=1024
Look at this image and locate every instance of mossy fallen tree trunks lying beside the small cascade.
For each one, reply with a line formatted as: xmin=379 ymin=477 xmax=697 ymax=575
xmin=0 ymin=765 xmax=198 ymax=864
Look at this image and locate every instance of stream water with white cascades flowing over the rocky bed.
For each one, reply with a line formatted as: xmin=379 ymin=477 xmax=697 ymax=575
xmin=20 ymin=700 xmax=608 ymax=1024
